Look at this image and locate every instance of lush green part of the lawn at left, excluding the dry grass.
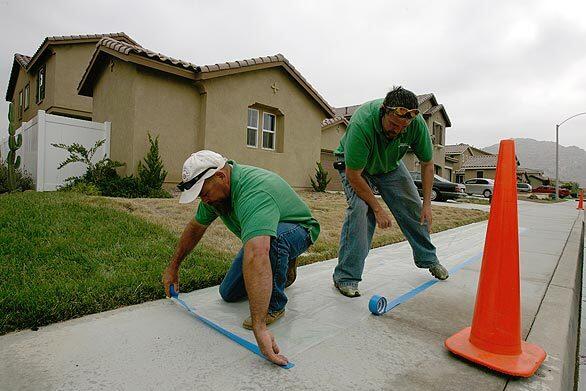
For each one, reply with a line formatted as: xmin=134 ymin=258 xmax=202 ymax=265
xmin=0 ymin=192 xmax=231 ymax=334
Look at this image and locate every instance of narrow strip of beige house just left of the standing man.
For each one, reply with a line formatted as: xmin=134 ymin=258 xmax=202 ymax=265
xmin=320 ymin=116 xmax=348 ymax=191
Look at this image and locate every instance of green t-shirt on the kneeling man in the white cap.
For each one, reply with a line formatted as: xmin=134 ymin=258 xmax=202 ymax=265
xmin=195 ymin=160 xmax=320 ymax=244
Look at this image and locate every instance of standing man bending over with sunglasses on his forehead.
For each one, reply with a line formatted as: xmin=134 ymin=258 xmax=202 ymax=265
xmin=333 ymin=87 xmax=448 ymax=297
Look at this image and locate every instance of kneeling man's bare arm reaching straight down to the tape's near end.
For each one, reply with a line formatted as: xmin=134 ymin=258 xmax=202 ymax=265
xmin=242 ymin=236 xmax=288 ymax=365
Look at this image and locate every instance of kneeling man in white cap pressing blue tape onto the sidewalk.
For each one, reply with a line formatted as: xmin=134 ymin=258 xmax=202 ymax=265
xmin=163 ymin=150 xmax=320 ymax=365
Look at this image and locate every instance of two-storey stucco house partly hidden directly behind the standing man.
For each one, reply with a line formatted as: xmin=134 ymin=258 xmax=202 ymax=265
xmin=321 ymin=94 xmax=455 ymax=190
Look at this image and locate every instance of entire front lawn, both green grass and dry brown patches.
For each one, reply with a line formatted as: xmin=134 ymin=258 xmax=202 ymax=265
xmin=0 ymin=192 xmax=488 ymax=335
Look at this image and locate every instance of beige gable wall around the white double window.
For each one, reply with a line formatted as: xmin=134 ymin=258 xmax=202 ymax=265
xmin=204 ymin=67 xmax=329 ymax=187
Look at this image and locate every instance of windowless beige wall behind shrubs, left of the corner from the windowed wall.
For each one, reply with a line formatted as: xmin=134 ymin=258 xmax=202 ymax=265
xmin=131 ymin=67 xmax=200 ymax=182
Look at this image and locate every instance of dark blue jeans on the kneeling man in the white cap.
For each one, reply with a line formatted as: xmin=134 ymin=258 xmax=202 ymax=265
xmin=220 ymin=223 xmax=311 ymax=312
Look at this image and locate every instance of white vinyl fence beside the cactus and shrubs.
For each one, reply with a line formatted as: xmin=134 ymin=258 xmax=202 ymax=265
xmin=0 ymin=110 xmax=110 ymax=191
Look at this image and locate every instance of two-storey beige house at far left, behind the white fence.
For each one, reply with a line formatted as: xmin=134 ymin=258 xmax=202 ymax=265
xmin=6 ymin=33 xmax=136 ymax=128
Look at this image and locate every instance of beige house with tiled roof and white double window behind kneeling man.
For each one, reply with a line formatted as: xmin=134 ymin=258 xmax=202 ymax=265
xmin=78 ymin=38 xmax=334 ymax=187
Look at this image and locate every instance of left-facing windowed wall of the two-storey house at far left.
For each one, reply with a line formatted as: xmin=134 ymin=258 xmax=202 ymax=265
xmin=11 ymin=56 xmax=55 ymax=129
